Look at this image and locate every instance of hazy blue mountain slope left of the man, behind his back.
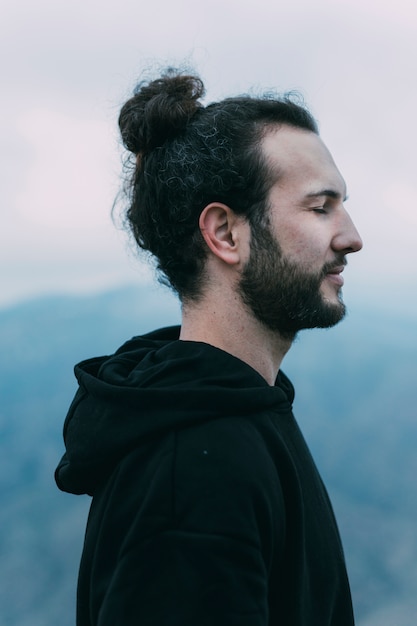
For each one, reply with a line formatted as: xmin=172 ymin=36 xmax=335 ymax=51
xmin=0 ymin=288 xmax=179 ymax=626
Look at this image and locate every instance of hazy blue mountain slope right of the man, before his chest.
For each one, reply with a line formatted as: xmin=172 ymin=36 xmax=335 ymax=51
xmin=286 ymin=307 xmax=417 ymax=626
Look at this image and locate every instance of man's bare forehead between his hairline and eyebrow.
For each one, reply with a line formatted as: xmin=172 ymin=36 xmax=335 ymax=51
xmin=262 ymin=126 xmax=346 ymax=197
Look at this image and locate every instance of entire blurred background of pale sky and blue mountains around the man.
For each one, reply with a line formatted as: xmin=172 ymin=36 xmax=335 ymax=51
xmin=0 ymin=0 xmax=417 ymax=626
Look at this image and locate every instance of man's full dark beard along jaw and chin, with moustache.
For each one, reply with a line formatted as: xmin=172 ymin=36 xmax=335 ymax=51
xmin=238 ymin=218 xmax=346 ymax=340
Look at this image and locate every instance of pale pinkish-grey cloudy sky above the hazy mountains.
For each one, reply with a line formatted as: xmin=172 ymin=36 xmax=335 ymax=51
xmin=0 ymin=0 xmax=417 ymax=311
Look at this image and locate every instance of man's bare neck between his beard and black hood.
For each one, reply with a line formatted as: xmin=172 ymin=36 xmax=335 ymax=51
xmin=180 ymin=297 xmax=292 ymax=385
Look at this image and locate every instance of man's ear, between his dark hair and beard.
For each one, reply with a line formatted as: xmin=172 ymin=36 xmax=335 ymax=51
xmin=199 ymin=202 xmax=243 ymax=265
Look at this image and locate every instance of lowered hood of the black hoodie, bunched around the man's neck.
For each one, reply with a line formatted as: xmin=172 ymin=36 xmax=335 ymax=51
xmin=55 ymin=326 xmax=294 ymax=494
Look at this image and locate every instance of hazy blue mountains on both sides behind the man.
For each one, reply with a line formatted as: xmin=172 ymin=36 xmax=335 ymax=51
xmin=0 ymin=287 xmax=417 ymax=626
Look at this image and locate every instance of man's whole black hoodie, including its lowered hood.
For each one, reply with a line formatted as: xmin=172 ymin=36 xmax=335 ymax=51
xmin=56 ymin=328 xmax=354 ymax=626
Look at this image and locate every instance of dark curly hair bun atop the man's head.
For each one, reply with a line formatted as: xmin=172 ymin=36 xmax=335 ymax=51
xmin=119 ymin=68 xmax=204 ymax=155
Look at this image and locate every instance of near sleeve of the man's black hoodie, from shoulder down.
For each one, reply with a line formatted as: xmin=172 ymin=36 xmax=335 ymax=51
xmin=90 ymin=420 xmax=285 ymax=626
